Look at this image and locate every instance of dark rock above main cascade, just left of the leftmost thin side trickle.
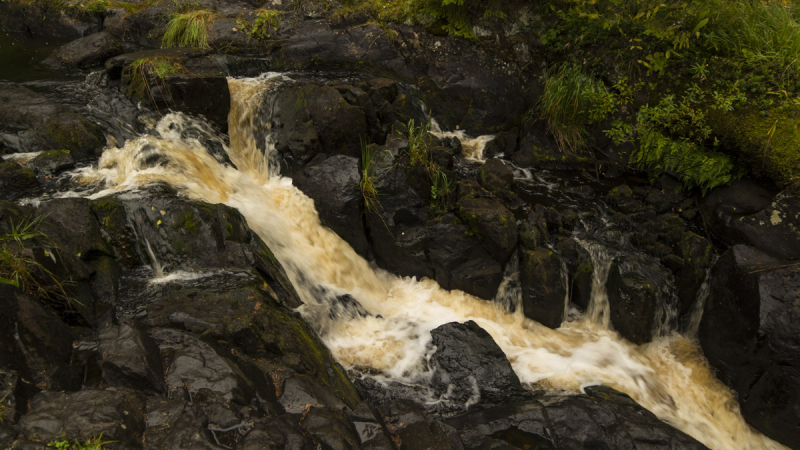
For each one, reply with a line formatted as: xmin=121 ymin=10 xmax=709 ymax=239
xmin=428 ymin=213 xmax=503 ymax=300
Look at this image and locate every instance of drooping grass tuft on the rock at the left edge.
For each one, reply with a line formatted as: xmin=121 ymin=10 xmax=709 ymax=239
xmin=0 ymin=217 xmax=73 ymax=303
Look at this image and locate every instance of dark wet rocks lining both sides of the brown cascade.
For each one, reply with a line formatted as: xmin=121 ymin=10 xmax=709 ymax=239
xmin=0 ymin=1 xmax=800 ymax=449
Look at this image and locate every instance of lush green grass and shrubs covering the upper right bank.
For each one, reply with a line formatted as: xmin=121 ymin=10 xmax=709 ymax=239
xmin=337 ymin=0 xmax=800 ymax=190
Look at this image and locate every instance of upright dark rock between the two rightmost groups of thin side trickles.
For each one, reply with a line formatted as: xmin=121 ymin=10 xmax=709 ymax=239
xmin=606 ymin=263 xmax=659 ymax=344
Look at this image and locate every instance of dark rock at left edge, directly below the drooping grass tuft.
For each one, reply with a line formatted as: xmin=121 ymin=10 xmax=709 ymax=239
xmin=0 ymin=284 xmax=74 ymax=379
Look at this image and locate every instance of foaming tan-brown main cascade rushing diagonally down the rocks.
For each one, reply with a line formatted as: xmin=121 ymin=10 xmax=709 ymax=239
xmin=79 ymin=75 xmax=781 ymax=449
